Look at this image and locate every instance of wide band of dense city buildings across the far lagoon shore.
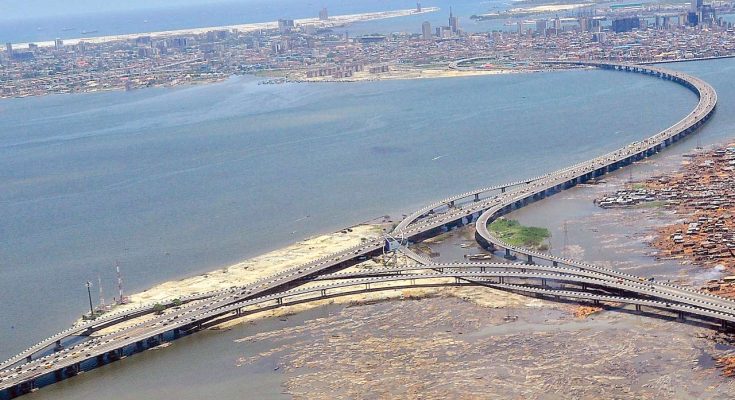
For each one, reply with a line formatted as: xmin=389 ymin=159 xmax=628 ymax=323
xmin=0 ymin=4 xmax=735 ymax=97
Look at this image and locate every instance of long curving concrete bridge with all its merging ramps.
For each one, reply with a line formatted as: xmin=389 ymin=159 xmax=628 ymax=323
xmin=0 ymin=59 xmax=724 ymax=398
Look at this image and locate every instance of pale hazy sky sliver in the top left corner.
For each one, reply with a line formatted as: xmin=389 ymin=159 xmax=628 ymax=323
xmin=0 ymin=0 xmax=236 ymax=20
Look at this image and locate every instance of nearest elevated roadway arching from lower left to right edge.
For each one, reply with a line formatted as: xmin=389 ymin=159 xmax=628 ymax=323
xmin=3 ymin=263 xmax=735 ymax=393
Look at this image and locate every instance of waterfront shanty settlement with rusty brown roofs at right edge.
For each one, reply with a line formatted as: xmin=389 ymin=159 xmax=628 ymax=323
xmin=594 ymin=139 xmax=735 ymax=288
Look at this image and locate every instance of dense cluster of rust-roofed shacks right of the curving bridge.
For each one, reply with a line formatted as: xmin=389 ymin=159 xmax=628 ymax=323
xmin=598 ymin=147 xmax=735 ymax=276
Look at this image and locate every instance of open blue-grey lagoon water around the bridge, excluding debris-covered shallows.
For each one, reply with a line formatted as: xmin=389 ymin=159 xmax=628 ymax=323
xmin=0 ymin=60 xmax=735 ymax=399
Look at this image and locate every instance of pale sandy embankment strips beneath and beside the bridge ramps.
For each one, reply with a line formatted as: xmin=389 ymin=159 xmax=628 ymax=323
xmin=89 ymin=216 xmax=551 ymax=335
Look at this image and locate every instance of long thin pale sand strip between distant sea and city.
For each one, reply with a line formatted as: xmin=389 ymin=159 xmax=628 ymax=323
xmin=13 ymin=7 xmax=439 ymax=47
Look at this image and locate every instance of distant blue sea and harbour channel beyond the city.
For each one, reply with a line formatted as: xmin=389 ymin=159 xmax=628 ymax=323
xmin=0 ymin=0 xmax=515 ymax=43
